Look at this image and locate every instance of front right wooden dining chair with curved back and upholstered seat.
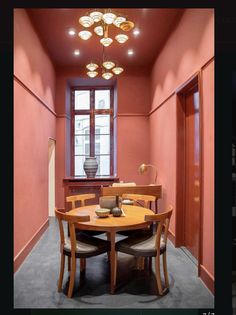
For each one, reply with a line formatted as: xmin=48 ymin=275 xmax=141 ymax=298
xmin=114 ymin=206 xmax=173 ymax=295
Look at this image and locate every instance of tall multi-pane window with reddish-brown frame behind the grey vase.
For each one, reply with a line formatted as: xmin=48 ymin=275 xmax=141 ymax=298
xmin=71 ymin=87 xmax=113 ymax=177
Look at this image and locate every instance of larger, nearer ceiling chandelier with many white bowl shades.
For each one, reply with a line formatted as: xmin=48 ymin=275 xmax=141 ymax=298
xmin=78 ymin=9 xmax=134 ymax=47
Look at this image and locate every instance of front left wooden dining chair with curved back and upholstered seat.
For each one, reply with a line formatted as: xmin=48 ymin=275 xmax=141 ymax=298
xmin=55 ymin=209 xmax=110 ymax=298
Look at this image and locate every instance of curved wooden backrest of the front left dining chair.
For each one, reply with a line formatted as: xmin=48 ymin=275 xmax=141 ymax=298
xmin=55 ymin=208 xmax=90 ymax=252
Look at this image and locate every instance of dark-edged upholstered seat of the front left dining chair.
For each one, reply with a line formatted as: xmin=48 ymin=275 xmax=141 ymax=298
xmin=64 ymin=233 xmax=111 ymax=258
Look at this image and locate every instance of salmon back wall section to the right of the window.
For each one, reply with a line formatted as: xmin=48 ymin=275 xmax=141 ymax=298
xmin=117 ymin=70 xmax=150 ymax=184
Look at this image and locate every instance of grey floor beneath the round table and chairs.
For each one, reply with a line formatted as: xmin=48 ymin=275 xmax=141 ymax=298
xmin=14 ymin=218 xmax=214 ymax=309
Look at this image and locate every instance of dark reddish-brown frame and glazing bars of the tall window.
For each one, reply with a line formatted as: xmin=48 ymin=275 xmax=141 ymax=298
xmin=71 ymin=86 xmax=114 ymax=177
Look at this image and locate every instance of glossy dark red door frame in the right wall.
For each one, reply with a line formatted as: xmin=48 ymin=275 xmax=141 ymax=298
xmin=175 ymin=71 xmax=203 ymax=276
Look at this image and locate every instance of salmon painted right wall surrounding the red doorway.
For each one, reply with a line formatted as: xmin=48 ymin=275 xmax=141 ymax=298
xmin=149 ymin=9 xmax=214 ymax=277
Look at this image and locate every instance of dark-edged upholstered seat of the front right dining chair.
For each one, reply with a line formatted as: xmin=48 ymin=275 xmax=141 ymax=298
xmin=116 ymin=233 xmax=166 ymax=257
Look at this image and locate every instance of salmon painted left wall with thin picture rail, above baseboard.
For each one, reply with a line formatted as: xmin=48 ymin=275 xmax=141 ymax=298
xmin=14 ymin=9 xmax=56 ymax=258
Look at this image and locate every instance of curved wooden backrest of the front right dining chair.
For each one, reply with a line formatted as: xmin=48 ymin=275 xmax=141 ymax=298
xmin=144 ymin=206 xmax=173 ymax=250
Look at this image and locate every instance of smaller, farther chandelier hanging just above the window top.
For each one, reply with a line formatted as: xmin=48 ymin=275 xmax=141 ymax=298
xmin=86 ymin=47 xmax=124 ymax=80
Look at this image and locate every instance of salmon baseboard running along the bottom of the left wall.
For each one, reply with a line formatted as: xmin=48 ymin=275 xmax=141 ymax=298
xmin=14 ymin=219 xmax=49 ymax=272
